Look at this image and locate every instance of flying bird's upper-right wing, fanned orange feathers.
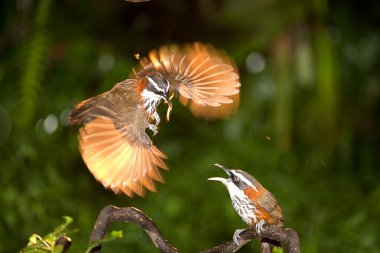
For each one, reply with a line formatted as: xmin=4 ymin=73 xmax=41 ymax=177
xmin=134 ymin=43 xmax=240 ymax=119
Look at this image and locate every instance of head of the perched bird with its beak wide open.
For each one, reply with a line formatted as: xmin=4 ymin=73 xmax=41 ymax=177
xmin=208 ymin=163 xmax=260 ymax=197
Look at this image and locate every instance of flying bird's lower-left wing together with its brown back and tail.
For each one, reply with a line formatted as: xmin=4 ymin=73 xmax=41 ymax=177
xmin=70 ymin=79 xmax=167 ymax=197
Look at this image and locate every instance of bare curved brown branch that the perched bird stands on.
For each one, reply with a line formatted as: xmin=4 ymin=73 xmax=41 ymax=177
xmin=90 ymin=206 xmax=300 ymax=253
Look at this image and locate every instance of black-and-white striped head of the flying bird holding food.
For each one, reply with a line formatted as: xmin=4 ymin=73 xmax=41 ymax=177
xmin=142 ymin=71 xmax=172 ymax=120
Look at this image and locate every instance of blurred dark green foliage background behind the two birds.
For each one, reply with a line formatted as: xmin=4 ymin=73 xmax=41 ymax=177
xmin=0 ymin=0 xmax=380 ymax=252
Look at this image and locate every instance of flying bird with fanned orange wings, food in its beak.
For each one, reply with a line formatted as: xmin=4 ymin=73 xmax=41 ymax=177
xmin=69 ymin=43 xmax=240 ymax=197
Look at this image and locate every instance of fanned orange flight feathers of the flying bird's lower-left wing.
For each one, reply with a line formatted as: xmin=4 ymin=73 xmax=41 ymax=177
xmin=73 ymin=96 xmax=168 ymax=197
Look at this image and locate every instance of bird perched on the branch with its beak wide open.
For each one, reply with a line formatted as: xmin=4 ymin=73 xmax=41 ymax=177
xmin=208 ymin=163 xmax=285 ymax=245
